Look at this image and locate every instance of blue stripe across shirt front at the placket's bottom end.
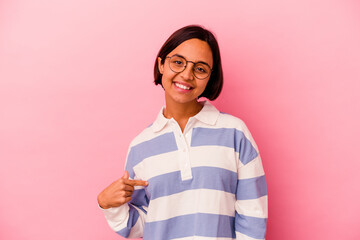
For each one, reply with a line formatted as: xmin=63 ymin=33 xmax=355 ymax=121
xmin=146 ymin=167 xmax=238 ymax=200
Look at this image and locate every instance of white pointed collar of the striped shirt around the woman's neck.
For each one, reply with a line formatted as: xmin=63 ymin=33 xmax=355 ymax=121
xmin=151 ymin=101 xmax=220 ymax=132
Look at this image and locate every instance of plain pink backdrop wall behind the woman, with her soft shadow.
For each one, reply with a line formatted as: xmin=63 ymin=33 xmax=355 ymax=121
xmin=0 ymin=0 xmax=360 ymax=240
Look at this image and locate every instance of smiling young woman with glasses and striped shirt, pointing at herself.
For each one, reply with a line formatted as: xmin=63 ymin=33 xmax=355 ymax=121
xmin=98 ymin=25 xmax=267 ymax=240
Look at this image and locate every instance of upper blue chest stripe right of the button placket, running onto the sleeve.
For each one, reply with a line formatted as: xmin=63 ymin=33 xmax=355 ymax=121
xmin=191 ymin=127 xmax=258 ymax=165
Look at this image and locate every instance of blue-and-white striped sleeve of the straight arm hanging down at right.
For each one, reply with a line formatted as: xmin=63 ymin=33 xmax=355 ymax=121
xmin=235 ymin=126 xmax=268 ymax=240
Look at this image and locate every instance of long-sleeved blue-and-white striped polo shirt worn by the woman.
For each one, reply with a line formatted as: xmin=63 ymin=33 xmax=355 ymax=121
xmin=103 ymin=101 xmax=267 ymax=240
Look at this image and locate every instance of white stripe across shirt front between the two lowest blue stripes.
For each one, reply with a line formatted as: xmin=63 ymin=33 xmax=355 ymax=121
xmin=146 ymin=189 xmax=236 ymax=222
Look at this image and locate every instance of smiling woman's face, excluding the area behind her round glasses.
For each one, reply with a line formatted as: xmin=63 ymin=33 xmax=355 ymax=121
xmin=158 ymin=38 xmax=213 ymax=106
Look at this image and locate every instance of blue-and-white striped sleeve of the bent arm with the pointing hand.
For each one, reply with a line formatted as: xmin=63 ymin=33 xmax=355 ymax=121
xmin=102 ymin=144 xmax=149 ymax=238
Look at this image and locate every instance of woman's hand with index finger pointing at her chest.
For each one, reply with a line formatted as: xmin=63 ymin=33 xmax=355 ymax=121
xmin=98 ymin=171 xmax=149 ymax=209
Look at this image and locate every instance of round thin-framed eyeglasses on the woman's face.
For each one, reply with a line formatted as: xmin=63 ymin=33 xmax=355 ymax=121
xmin=166 ymin=55 xmax=212 ymax=79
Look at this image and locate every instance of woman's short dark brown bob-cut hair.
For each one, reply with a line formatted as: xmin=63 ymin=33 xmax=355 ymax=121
xmin=154 ymin=25 xmax=223 ymax=100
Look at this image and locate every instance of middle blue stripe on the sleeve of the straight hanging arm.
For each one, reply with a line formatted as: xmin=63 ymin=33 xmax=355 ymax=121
xmin=236 ymin=175 xmax=267 ymax=200
